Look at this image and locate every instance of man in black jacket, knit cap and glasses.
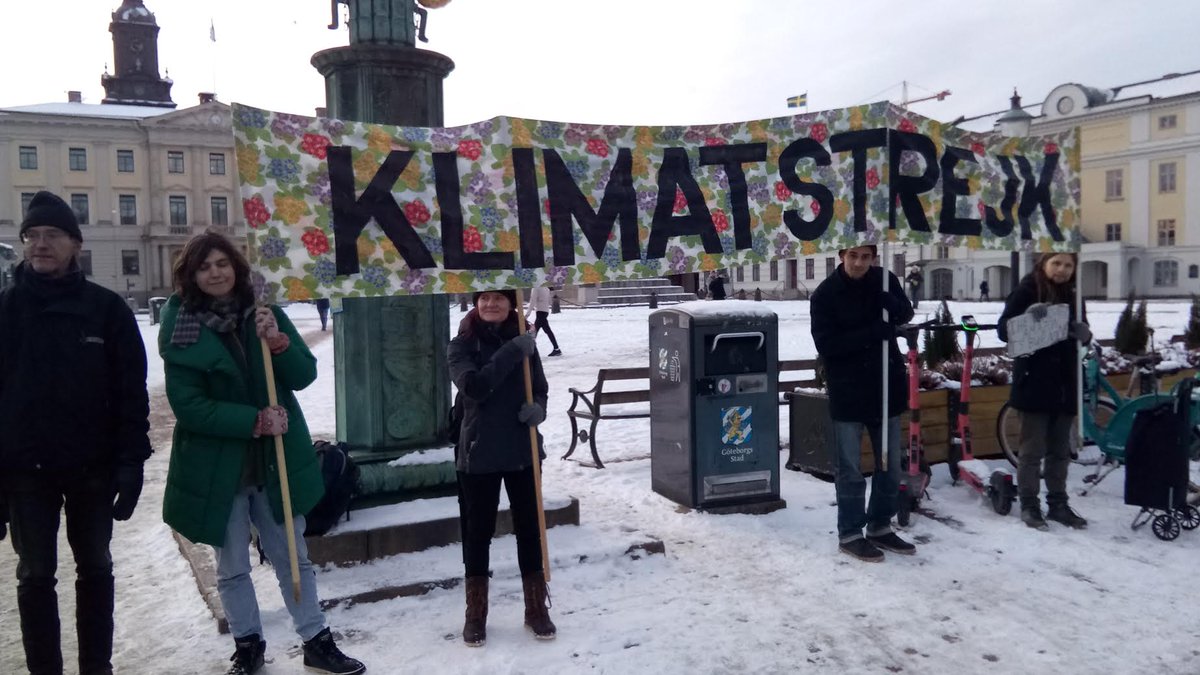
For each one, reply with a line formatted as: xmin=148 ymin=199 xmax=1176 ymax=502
xmin=0 ymin=192 xmax=150 ymax=674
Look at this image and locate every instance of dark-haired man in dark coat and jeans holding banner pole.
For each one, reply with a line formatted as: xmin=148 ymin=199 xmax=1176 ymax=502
xmin=810 ymin=246 xmax=916 ymax=562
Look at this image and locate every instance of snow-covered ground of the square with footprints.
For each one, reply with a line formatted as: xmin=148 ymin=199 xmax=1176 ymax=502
xmin=0 ymin=296 xmax=1200 ymax=674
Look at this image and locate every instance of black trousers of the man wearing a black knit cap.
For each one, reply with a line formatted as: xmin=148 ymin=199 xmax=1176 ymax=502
xmin=5 ymin=471 xmax=113 ymax=675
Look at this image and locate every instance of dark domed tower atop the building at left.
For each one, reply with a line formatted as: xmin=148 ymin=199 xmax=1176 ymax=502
xmin=100 ymin=0 xmax=175 ymax=108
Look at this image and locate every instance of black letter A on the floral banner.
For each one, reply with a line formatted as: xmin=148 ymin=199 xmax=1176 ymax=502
xmin=646 ymin=148 xmax=722 ymax=259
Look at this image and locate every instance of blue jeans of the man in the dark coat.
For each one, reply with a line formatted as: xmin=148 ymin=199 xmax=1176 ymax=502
xmin=830 ymin=416 xmax=900 ymax=543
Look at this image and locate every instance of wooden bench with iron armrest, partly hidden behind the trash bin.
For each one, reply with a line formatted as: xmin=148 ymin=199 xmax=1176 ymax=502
xmin=562 ymin=359 xmax=817 ymax=468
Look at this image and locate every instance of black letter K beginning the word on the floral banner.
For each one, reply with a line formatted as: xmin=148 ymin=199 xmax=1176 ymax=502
xmin=328 ymin=145 xmax=436 ymax=275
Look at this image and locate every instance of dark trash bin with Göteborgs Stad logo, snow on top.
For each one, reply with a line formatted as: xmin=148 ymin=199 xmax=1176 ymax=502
xmin=649 ymin=301 xmax=786 ymax=513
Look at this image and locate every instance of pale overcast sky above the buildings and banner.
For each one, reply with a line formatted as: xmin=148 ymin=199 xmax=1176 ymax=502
xmin=0 ymin=0 xmax=1200 ymax=125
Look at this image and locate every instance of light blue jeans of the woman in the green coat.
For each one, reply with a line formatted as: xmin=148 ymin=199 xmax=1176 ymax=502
xmin=214 ymin=488 xmax=325 ymax=641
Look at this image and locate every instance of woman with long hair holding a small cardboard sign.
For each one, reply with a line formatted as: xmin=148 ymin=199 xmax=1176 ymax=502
xmin=997 ymin=253 xmax=1092 ymax=530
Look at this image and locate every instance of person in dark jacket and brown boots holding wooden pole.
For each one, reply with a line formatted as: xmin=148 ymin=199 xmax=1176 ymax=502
xmin=446 ymin=291 xmax=557 ymax=647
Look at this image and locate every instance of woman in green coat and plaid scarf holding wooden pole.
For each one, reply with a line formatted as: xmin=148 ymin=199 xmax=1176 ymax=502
xmin=158 ymin=232 xmax=366 ymax=675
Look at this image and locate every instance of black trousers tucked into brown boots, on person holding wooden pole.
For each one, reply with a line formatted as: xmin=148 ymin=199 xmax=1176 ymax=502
xmin=458 ymin=466 xmax=542 ymax=577
